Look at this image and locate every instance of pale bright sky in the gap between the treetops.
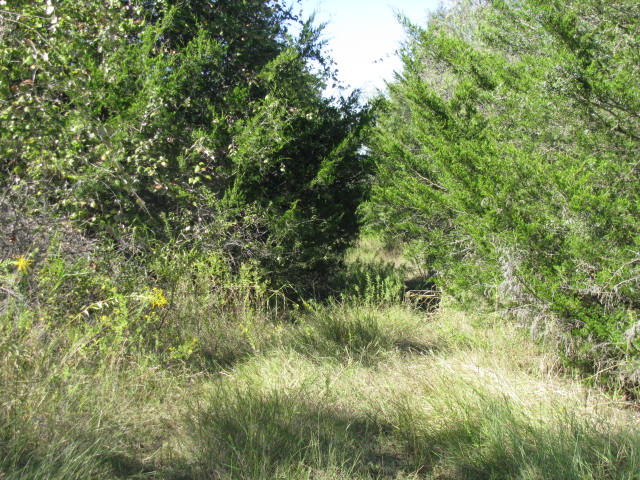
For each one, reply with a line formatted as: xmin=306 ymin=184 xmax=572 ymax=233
xmin=292 ymin=0 xmax=440 ymax=96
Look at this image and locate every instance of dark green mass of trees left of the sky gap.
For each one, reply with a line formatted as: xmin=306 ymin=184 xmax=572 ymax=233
xmin=0 ymin=0 xmax=370 ymax=294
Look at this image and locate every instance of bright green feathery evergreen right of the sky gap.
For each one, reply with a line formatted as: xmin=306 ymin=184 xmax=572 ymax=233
xmin=365 ymin=0 xmax=640 ymax=371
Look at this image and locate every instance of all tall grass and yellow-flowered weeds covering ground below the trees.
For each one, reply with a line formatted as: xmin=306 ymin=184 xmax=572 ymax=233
xmin=0 ymin=235 xmax=640 ymax=480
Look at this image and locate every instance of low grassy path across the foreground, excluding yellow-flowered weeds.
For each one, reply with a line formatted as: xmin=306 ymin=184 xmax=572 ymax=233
xmin=0 ymin=305 xmax=640 ymax=480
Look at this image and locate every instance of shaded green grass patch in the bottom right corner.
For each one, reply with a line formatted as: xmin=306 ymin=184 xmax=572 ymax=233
xmin=398 ymin=394 xmax=640 ymax=480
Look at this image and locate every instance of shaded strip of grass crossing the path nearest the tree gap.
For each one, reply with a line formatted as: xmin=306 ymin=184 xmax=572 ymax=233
xmin=189 ymin=305 xmax=443 ymax=371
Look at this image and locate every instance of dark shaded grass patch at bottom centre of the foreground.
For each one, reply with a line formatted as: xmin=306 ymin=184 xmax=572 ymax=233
xmin=184 ymin=388 xmax=416 ymax=479
